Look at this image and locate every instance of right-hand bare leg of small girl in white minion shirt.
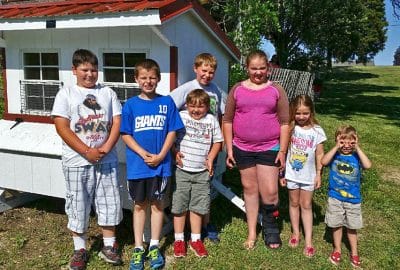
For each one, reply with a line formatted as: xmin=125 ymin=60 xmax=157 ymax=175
xmin=300 ymin=190 xmax=313 ymax=247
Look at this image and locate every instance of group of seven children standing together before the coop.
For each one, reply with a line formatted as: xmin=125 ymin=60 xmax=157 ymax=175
xmin=52 ymin=49 xmax=371 ymax=270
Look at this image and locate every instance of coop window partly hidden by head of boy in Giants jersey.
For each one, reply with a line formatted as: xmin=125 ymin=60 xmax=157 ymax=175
xmin=103 ymin=52 xmax=146 ymax=83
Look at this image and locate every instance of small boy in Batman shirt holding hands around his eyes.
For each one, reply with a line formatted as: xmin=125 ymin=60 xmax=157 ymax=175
xmin=321 ymin=125 xmax=372 ymax=267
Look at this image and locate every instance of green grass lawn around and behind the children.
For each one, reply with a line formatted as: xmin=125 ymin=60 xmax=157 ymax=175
xmin=0 ymin=67 xmax=400 ymax=269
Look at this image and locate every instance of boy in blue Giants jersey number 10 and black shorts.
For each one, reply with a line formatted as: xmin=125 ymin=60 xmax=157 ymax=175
xmin=121 ymin=59 xmax=184 ymax=270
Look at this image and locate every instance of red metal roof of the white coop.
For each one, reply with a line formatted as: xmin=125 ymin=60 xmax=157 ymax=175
xmin=0 ymin=0 xmax=240 ymax=59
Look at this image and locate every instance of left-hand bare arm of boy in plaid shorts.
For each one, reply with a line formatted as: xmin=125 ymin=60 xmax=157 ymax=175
xmin=53 ymin=116 xmax=104 ymax=163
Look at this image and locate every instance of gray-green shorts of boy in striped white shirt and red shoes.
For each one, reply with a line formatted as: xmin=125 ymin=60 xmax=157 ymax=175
xmin=171 ymin=168 xmax=211 ymax=215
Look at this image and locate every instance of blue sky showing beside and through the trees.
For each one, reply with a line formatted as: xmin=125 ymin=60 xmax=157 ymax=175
xmin=262 ymin=0 xmax=400 ymax=66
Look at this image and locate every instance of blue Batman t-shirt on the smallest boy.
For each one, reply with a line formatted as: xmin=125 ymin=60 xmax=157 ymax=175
xmin=328 ymin=153 xmax=361 ymax=203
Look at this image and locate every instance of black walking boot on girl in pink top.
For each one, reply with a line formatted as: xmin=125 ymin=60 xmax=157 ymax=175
xmin=261 ymin=204 xmax=282 ymax=249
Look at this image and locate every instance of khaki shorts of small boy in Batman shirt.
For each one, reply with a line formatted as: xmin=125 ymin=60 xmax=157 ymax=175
xmin=325 ymin=197 xmax=363 ymax=230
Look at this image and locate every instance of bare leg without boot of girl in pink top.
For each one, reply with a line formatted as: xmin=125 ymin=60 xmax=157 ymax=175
xmin=240 ymin=167 xmax=259 ymax=240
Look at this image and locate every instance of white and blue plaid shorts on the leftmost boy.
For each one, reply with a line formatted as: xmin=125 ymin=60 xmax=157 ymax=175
xmin=63 ymin=163 xmax=122 ymax=233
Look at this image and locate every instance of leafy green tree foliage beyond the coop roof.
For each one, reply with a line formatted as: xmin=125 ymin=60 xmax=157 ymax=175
xmin=206 ymin=0 xmax=388 ymax=68
